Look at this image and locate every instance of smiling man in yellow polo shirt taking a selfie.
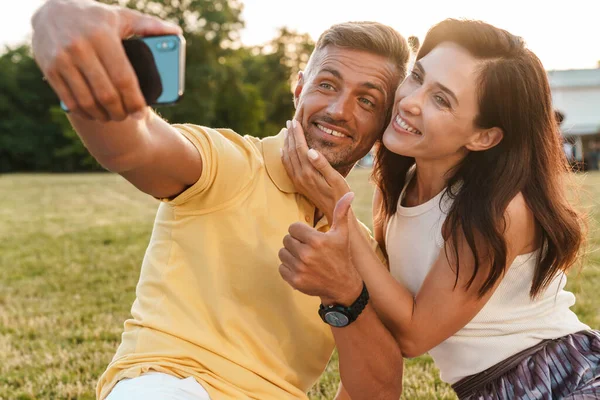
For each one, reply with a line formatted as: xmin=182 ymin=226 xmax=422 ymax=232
xmin=32 ymin=0 xmax=408 ymax=400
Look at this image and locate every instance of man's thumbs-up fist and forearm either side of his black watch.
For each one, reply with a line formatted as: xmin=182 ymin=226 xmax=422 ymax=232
xmin=279 ymin=194 xmax=403 ymax=400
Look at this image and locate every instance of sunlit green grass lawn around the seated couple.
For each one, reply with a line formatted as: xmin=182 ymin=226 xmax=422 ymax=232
xmin=0 ymin=170 xmax=600 ymax=400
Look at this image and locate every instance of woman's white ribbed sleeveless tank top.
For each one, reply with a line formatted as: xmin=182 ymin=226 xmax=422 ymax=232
xmin=385 ymin=170 xmax=589 ymax=384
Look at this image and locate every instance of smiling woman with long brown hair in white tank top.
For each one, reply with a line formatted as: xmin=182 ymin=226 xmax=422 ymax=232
xmin=282 ymin=20 xmax=600 ymax=399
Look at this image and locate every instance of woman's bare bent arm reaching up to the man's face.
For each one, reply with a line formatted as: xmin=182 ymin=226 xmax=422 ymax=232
xmin=288 ymin=126 xmax=535 ymax=357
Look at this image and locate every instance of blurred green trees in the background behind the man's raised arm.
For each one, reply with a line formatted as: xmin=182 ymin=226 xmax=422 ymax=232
xmin=0 ymin=0 xmax=314 ymax=172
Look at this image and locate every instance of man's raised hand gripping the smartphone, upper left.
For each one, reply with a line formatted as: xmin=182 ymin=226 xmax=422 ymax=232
xmin=32 ymin=0 xmax=182 ymax=122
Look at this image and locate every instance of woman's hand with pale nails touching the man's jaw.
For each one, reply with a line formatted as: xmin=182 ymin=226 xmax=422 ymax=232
xmin=281 ymin=119 xmax=350 ymax=223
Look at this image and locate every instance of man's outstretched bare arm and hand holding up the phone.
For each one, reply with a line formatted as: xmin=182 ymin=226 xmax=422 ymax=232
xmin=32 ymin=0 xmax=202 ymax=197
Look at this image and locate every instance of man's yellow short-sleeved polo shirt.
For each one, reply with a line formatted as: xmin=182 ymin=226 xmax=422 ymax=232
xmin=97 ymin=125 xmax=346 ymax=400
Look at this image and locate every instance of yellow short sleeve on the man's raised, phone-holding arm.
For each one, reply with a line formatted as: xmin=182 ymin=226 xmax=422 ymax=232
xmin=161 ymin=124 xmax=261 ymax=212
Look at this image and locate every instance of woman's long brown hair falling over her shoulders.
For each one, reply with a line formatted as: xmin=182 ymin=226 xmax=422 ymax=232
xmin=373 ymin=19 xmax=585 ymax=298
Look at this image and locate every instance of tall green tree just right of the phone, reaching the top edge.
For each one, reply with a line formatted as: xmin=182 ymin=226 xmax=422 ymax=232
xmin=105 ymin=0 xmax=264 ymax=135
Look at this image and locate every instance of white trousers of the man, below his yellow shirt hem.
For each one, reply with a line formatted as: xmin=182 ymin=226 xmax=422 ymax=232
xmin=106 ymin=372 xmax=210 ymax=400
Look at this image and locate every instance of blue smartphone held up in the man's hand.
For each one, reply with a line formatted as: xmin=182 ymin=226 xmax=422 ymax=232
xmin=60 ymin=35 xmax=185 ymax=112
